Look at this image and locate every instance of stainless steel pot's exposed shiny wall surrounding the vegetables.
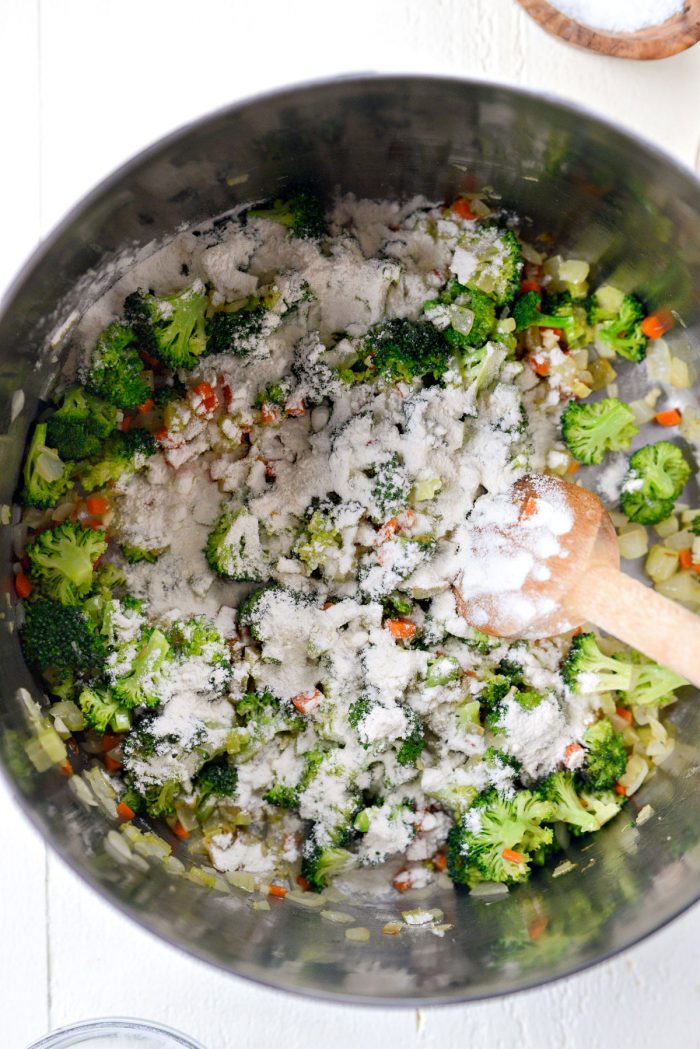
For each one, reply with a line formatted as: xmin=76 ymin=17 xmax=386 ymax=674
xmin=0 ymin=77 xmax=700 ymax=1004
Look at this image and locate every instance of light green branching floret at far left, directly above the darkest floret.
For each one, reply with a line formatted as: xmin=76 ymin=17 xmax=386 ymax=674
xmin=25 ymin=521 xmax=107 ymax=604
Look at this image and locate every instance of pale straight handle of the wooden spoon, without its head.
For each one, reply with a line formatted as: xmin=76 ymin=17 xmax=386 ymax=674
xmin=571 ymin=565 xmax=700 ymax=688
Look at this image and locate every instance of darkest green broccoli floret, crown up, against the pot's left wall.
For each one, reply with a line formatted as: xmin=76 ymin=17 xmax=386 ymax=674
xmin=20 ymin=598 xmax=107 ymax=679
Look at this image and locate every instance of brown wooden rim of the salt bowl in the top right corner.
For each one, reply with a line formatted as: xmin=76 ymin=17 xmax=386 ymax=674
xmin=517 ymin=0 xmax=700 ymax=59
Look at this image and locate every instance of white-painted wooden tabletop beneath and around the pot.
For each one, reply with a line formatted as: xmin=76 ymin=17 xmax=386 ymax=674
xmin=0 ymin=0 xmax=700 ymax=1049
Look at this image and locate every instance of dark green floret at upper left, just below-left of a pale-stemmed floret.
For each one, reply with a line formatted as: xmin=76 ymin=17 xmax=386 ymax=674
xmin=85 ymin=323 xmax=151 ymax=409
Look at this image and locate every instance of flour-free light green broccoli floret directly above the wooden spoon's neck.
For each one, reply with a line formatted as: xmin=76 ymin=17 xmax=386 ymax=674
xmin=561 ymin=397 xmax=639 ymax=466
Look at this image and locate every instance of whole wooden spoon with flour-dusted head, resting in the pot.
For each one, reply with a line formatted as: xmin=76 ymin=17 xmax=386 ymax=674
xmin=454 ymin=475 xmax=700 ymax=687
